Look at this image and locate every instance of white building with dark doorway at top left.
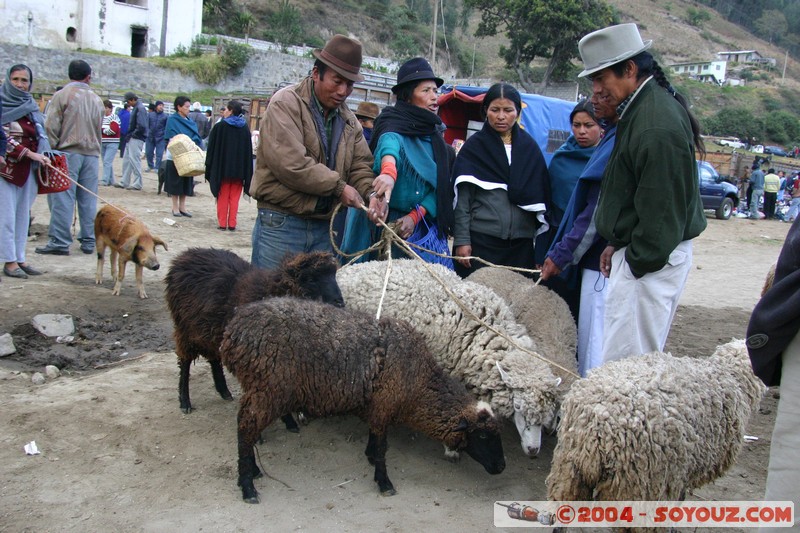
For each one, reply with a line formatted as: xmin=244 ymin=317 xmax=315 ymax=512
xmin=0 ymin=0 xmax=203 ymax=57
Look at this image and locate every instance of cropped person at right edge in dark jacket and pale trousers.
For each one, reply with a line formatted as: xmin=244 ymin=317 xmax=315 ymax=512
xmin=747 ymin=219 xmax=800 ymax=528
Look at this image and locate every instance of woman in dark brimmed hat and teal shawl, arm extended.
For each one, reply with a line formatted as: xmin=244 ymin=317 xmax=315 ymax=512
xmin=342 ymin=57 xmax=454 ymax=268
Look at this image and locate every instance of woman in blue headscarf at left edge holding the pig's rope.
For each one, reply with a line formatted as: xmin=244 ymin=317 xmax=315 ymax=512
xmin=0 ymin=64 xmax=50 ymax=279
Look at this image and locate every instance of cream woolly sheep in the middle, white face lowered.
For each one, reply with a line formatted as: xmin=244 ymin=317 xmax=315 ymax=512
xmin=336 ymin=259 xmax=559 ymax=458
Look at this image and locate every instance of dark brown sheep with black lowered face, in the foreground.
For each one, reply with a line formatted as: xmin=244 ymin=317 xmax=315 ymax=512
xmin=220 ymin=298 xmax=505 ymax=503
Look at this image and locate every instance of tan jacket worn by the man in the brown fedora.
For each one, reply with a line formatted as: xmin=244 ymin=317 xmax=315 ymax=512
xmin=250 ymin=77 xmax=375 ymax=219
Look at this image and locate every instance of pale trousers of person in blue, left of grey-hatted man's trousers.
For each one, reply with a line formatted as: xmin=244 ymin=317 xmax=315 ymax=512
xmin=578 ymin=268 xmax=608 ymax=378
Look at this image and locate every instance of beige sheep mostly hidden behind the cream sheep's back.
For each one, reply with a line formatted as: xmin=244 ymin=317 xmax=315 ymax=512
xmin=467 ymin=267 xmax=578 ymax=388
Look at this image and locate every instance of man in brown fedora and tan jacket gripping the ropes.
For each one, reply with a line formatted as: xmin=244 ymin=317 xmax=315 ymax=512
xmin=250 ymin=35 xmax=386 ymax=269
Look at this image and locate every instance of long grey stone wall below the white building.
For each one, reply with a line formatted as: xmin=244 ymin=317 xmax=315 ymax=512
xmin=0 ymin=43 xmax=313 ymax=99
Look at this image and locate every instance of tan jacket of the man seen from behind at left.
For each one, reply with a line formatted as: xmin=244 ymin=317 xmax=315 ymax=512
xmin=44 ymin=81 xmax=105 ymax=156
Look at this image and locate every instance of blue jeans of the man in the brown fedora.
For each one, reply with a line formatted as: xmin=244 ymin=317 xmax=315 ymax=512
xmin=250 ymin=209 xmax=333 ymax=270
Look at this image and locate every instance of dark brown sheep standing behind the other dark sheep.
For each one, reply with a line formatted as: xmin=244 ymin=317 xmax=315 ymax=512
xmin=166 ymin=248 xmax=344 ymax=416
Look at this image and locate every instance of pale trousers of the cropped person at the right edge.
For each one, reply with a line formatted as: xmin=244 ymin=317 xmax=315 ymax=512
xmin=761 ymin=334 xmax=800 ymax=531
